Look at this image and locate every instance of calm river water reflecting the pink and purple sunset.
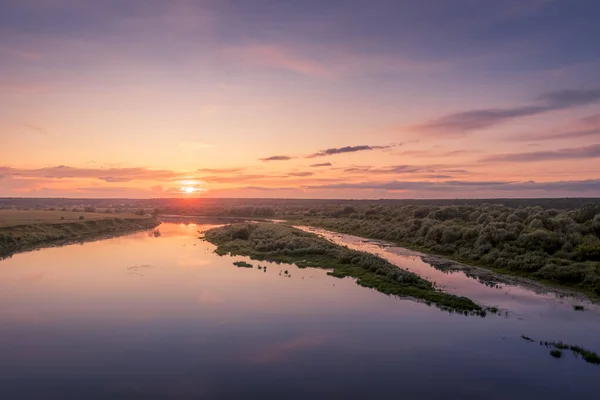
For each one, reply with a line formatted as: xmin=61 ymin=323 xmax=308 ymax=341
xmin=0 ymin=223 xmax=600 ymax=399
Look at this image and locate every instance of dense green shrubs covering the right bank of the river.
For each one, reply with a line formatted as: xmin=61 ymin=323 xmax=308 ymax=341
xmin=296 ymin=204 xmax=600 ymax=295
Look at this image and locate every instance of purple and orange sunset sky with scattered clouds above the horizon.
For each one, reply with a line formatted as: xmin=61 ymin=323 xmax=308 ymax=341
xmin=0 ymin=0 xmax=600 ymax=198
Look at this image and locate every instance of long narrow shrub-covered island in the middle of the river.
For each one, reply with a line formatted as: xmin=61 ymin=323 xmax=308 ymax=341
xmin=205 ymin=223 xmax=485 ymax=315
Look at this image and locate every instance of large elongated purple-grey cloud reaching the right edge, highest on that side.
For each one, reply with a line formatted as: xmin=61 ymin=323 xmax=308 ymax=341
xmin=410 ymin=89 xmax=600 ymax=134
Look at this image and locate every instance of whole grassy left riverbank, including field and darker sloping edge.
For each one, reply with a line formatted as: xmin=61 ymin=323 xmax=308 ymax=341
xmin=0 ymin=210 xmax=160 ymax=257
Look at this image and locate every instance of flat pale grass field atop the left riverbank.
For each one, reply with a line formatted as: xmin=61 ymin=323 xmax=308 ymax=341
xmin=0 ymin=210 xmax=148 ymax=228
